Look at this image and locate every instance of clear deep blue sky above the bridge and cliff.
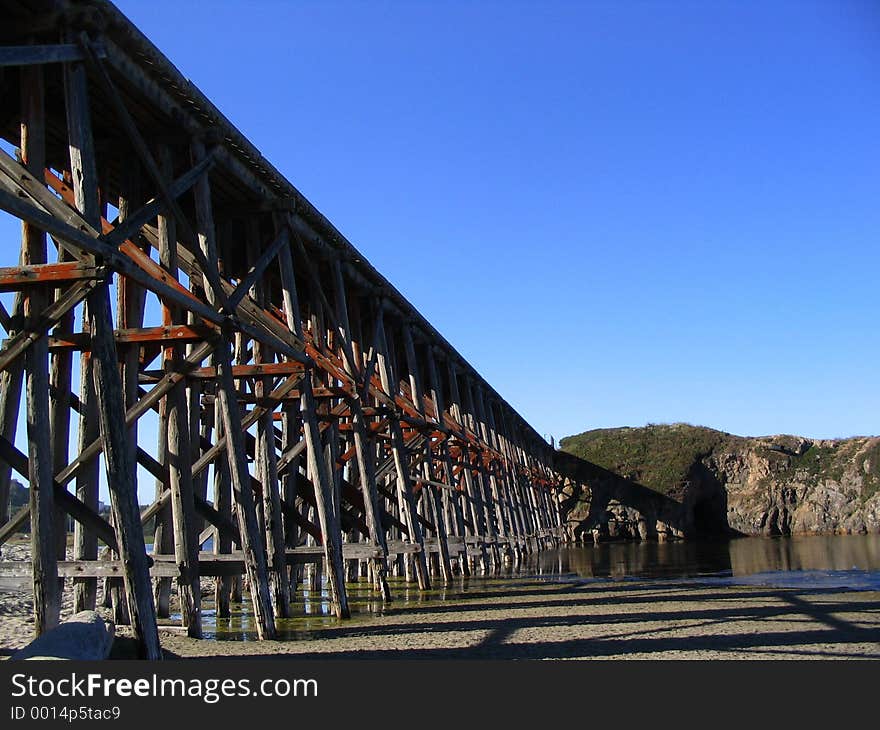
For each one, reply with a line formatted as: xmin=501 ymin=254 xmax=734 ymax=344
xmin=6 ymin=0 xmax=880 ymax=450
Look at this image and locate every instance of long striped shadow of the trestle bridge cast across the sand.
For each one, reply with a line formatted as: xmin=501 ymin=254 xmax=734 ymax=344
xmin=156 ymin=584 xmax=880 ymax=660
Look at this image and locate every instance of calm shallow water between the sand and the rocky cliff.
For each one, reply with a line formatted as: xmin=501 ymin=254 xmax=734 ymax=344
xmin=204 ymin=535 xmax=880 ymax=641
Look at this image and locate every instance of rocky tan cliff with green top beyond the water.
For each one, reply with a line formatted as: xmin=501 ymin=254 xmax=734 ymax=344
xmin=560 ymin=424 xmax=880 ymax=537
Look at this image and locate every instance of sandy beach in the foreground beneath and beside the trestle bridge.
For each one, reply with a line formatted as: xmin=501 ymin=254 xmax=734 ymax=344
xmin=0 ymin=536 xmax=880 ymax=659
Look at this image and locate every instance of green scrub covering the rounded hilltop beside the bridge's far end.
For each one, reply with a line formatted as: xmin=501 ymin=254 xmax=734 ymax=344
xmin=559 ymin=423 xmax=737 ymax=495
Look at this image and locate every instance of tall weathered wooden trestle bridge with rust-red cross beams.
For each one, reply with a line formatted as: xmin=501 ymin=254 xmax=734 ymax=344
xmin=0 ymin=0 xmax=576 ymax=658
